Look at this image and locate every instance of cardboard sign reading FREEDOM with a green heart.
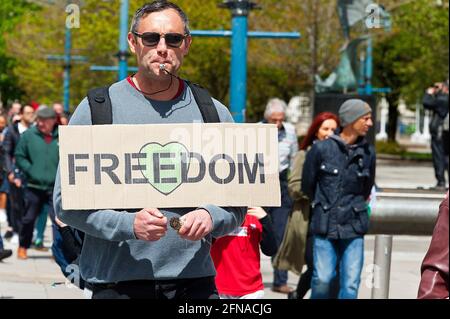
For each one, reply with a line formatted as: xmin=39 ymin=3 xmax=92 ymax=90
xmin=59 ymin=123 xmax=280 ymax=210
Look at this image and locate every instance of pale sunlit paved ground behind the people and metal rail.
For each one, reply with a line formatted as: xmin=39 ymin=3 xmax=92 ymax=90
xmin=0 ymin=160 xmax=442 ymax=299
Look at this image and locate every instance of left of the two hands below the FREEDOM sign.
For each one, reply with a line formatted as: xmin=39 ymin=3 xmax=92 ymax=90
xmin=133 ymin=208 xmax=167 ymax=241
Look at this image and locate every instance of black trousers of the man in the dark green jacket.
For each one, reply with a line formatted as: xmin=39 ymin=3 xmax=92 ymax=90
xmin=19 ymin=187 xmax=55 ymax=248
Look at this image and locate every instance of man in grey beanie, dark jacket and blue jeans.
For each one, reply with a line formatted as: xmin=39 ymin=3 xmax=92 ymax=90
xmin=301 ymin=99 xmax=375 ymax=299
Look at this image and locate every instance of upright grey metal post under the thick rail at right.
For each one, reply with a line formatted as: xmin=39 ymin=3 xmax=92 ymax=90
xmin=372 ymin=235 xmax=392 ymax=299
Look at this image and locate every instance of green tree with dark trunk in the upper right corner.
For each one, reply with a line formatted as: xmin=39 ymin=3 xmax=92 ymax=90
xmin=374 ymin=0 xmax=449 ymax=141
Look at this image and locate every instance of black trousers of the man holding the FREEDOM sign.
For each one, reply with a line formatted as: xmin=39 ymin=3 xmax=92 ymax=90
xmin=92 ymin=277 xmax=219 ymax=300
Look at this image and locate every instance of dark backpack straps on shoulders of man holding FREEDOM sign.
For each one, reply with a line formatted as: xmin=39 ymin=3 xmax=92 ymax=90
xmin=87 ymin=81 xmax=220 ymax=125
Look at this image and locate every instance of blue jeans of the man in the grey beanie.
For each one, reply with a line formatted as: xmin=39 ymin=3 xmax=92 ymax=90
xmin=311 ymin=236 xmax=364 ymax=299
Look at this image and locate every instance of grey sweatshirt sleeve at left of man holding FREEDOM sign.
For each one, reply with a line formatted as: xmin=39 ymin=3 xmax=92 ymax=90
xmin=53 ymin=99 xmax=136 ymax=241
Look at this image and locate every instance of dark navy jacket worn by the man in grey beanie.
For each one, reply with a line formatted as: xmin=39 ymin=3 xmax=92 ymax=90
xmin=302 ymin=135 xmax=376 ymax=239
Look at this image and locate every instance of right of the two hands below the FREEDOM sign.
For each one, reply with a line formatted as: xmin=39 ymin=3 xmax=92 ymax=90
xmin=178 ymin=209 xmax=213 ymax=241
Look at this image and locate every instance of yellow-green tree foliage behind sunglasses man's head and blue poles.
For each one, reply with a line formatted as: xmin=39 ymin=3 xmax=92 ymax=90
xmin=6 ymin=0 xmax=342 ymax=121
